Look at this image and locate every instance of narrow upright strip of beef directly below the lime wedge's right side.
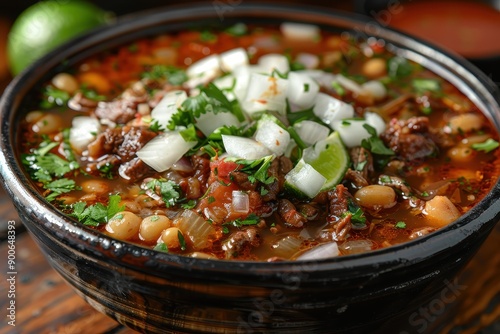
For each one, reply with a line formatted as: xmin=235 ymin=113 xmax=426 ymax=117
xmin=321 ymin=184 xmax=354 ymax=241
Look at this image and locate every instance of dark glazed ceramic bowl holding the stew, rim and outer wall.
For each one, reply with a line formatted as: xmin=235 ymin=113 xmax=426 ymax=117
xmin=0 ymin=1 xmax=500 ymax=333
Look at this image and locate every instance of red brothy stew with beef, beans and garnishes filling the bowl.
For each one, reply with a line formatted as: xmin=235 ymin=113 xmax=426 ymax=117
xmin=20 ymin=25 xmax=500 ymax=261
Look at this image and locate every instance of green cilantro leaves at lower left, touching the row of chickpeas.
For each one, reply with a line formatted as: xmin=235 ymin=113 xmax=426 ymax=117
xmin=69 ymin=195 xmax=125 ymax=226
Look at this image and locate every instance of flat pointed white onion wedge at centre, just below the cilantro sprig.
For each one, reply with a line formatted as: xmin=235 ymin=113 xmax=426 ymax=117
xmin=222 ymin=135 xmax=271 ymax=160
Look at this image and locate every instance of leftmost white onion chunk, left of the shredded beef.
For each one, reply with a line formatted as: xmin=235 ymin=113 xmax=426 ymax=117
xmin=69 ymin=116 xmax=101 ymax=153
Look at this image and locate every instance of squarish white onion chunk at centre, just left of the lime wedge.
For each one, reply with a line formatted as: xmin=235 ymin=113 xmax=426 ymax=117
xmin=255 ymin=120 xmax=290 ymax=156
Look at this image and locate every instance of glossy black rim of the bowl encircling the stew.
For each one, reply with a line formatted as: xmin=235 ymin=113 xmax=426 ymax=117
xmin=0 ymin=3 xmax=500 ymax=276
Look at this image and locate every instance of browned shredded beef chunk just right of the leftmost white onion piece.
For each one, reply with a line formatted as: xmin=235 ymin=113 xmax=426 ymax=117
xmin=86 ymin=126 xmax=157 ymax=182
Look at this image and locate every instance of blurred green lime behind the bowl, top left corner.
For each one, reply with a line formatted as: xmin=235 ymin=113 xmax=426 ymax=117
xmin=7 ymin=0 xmax=112 ymax=75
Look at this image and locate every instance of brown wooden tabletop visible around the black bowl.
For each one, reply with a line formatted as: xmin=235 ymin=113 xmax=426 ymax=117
xmin=0 ymin=5 xmax=500 ymax=334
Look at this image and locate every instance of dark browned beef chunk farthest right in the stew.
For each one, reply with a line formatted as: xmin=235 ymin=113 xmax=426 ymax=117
xmin=380 ymin=117 xmax=438 ymax=162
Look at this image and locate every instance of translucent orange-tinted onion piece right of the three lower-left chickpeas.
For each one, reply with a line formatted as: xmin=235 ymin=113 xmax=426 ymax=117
xmin=173 ymin=210 xmax=215 ymax=250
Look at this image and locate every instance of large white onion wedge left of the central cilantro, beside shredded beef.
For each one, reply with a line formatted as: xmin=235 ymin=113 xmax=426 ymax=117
xmin=136 ymin=131 xmax=196 ymax=172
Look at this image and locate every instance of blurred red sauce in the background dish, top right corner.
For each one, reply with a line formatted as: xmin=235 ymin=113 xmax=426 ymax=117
xmin=386 ymin=0 xmax=500 ymax=59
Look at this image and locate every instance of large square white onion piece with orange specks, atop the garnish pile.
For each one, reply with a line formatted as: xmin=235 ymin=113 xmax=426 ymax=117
xmin=242 ymin=73 xmax=288 ymax=116
